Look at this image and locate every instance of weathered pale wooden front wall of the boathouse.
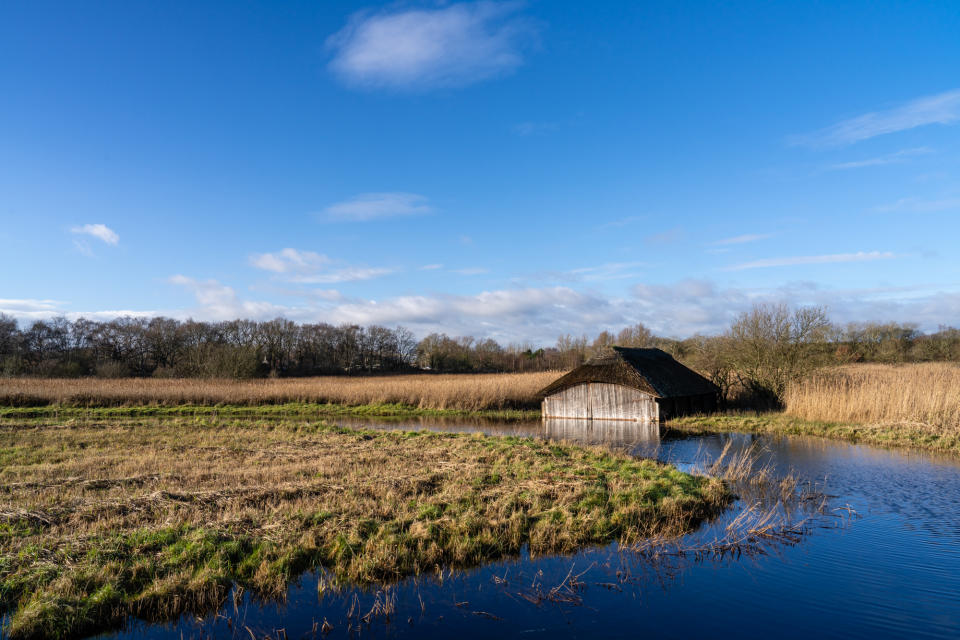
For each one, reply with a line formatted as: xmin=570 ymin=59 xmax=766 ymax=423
xmin=543 ymin=382 xmax=660 ymax=422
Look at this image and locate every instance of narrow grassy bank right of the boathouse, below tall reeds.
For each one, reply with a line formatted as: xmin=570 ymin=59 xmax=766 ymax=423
xmin=666 ymin=412 xmax=960 ymax=455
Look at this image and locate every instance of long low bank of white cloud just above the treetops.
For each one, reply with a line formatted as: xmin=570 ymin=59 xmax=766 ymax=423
xmin=11 ymin=275 xmax=960 ymax=345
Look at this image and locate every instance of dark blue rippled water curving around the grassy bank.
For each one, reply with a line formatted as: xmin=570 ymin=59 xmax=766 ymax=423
xmin=103 ymin=419 xmax=960 ymax=640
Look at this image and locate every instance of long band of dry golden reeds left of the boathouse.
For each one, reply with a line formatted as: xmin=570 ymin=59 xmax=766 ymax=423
xmin=0 ymin=371 xmax=562 ymax=411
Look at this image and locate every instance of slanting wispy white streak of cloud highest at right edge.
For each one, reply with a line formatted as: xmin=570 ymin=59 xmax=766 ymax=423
xmin=790 ymin=89 xmax=960 ymax=148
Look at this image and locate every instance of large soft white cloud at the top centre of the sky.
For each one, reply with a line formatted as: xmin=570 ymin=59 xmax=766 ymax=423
xmin=327 ymin=2 xmax=535 ymax=90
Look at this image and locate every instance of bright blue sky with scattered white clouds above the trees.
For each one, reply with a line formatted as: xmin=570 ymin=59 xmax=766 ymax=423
xmin=0 ymin=1 xmax=960 ymax=344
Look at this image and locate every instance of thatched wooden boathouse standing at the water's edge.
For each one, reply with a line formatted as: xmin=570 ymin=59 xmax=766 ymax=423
xmin=540 ymin=347 xmax=720 ymax=422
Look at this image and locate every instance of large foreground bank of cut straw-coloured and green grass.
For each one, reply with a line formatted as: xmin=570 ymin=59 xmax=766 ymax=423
xmin=0 ymin=416 xmax=729 ymax=637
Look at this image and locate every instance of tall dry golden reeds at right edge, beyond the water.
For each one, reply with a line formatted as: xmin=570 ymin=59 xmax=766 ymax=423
xmin=786 ymin=363 xmax=960 ymax=434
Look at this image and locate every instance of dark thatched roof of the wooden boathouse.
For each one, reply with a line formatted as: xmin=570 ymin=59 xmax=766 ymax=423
xmin=540 ymin=347 xmax=720 ymax=398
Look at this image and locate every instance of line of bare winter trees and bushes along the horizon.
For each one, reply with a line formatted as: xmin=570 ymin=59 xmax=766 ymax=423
xmin=0 ymin=305 xmax=960 ymax=397
